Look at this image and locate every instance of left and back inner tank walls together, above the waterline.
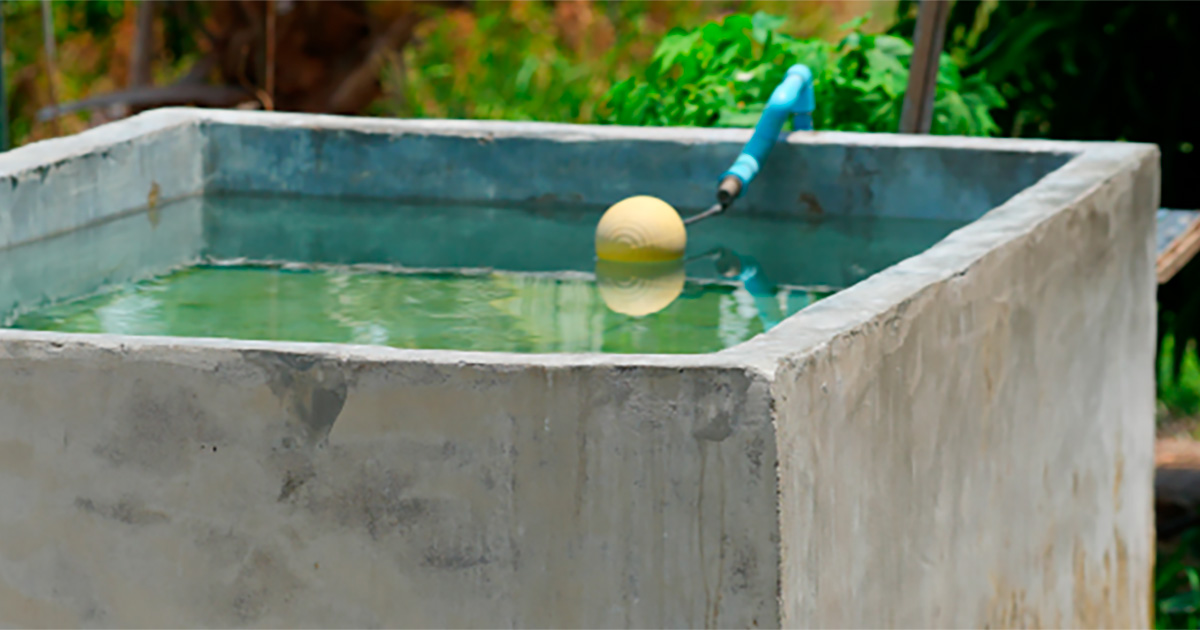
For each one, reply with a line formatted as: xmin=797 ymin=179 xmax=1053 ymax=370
xmin=0 ymin=109 xmax=1072 ymax=237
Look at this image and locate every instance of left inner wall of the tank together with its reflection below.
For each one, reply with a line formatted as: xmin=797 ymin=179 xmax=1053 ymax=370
xmin=0 ymin=112 xmax=205 ymax=325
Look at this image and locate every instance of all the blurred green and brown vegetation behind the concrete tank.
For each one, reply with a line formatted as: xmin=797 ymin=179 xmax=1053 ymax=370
xmin=0 ymin=0 xmax=1200 ymax=628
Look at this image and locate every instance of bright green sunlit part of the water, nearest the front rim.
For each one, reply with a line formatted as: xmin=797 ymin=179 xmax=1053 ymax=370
xmin=13 ymin=265 xmax=823 ymax=353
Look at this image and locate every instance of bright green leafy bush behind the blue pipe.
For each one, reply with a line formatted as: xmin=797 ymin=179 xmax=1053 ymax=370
xmin=604 ymin=12 xmax=1004 ymax=136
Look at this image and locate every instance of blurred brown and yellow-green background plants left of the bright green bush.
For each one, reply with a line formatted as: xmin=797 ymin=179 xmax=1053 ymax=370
xmin=0 ymin=0 xmax=895 ymax=137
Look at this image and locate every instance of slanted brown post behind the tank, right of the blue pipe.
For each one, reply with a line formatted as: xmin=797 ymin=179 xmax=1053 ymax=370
xmin=900 ymin=0 xmax=953 ymax=133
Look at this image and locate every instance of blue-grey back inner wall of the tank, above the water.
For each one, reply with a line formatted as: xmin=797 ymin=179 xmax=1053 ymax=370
xmin=204 ymin=114 xmax=1072 ymax=221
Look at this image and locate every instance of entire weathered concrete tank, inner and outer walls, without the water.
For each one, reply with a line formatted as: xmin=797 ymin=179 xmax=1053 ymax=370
xmin=0 ymin=110 xmax=1159 ymax=628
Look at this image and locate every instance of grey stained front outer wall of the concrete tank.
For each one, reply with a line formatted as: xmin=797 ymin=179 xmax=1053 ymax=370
xmin=0 ymin=332 xmax=779 ymax=628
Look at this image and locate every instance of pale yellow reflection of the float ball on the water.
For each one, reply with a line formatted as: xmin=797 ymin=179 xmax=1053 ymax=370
xmin=596 ymin=258 xmax=686 ymax=317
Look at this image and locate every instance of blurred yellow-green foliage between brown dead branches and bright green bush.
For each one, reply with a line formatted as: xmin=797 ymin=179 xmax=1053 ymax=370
xmin=388 ymin=1 xmax=709 ymax=122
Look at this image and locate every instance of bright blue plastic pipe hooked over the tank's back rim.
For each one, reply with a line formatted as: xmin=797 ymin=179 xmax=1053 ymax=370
xmin=721 ymin=64 xmax=816 ymax=192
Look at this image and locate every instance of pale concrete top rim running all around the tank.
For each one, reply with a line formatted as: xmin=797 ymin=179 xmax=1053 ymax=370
xmin=0 ymin=108 xmax=1158 ymax=378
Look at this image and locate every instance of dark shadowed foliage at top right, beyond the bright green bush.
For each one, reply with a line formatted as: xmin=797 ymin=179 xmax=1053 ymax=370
xmin=889 ymin=0 xmax=1200 ymax=209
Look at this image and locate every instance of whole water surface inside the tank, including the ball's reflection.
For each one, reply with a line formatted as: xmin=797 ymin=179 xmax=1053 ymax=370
xmin=0 ymin=197 xmax=958 ymax=353
